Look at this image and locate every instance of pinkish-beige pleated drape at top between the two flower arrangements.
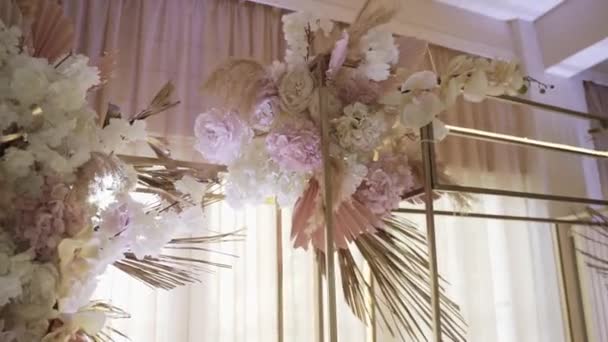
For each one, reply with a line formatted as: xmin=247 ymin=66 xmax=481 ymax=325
xmin=64 ymin=0 xmax=284 ymax=152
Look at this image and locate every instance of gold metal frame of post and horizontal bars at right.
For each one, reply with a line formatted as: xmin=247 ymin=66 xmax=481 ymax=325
xmin=404 ymin=96 xmax=608 ymax=342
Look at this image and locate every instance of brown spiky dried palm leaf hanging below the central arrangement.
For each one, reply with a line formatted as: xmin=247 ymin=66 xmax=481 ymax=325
xmin=317 ymin=216 xmax=466 ymax=341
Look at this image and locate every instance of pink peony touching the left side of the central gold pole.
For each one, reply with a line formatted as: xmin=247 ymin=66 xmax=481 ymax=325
xmin=266 ymin=120 xmax=321 ymax=172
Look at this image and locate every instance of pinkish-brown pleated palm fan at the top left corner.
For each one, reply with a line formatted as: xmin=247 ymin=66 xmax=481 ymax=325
xmin=22 ymin=0 xmax=75 ymax=61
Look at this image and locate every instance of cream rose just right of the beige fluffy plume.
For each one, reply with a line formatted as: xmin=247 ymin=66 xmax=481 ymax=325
xmin=279 ymin=68 xmax=315 ymax=114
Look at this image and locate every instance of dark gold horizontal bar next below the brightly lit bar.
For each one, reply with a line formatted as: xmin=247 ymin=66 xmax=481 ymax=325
xmin=435 ymin=184 xmax=608 ymax=206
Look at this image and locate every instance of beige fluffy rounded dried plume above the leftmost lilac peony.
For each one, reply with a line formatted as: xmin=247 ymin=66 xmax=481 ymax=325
xmin=202 ymin=59 xmax=276 ymax=115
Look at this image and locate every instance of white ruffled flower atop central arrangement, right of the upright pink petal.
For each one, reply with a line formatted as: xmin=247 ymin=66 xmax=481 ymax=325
xmin=359 ymin=28 xmax=399 ymax=81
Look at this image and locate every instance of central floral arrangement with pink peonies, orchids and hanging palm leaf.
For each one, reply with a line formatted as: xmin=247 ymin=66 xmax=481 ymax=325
xmin=194 ymin=1 xmax=526 ymax=340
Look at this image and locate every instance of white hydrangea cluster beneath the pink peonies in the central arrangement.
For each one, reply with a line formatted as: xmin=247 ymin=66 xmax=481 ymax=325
xmin=225 ymin=139 xmax=310 ymax=209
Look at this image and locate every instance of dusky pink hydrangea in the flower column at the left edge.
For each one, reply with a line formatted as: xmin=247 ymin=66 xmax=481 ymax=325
xmin=13 ymin=177 xmax=86 ymax=260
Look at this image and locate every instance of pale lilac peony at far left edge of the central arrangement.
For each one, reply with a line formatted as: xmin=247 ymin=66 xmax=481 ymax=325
xmin=194 ymin=108 xmax=253 ymax=165
